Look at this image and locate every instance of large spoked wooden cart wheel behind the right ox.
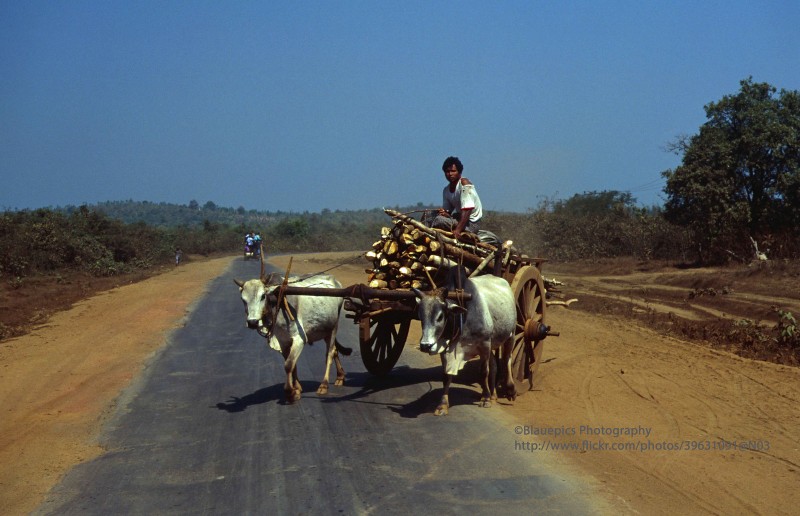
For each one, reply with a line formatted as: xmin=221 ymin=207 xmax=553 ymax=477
xmin=511 ymin=265 xmax=546 ymax=394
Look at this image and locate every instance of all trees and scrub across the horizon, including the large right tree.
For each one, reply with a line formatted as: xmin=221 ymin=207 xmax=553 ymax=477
xmin=0 ymin=79 xmax=800 ymax=358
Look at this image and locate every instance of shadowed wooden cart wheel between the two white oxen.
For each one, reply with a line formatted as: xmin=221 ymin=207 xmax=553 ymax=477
xmin=359 ymin=314 xmax=411 ymax=376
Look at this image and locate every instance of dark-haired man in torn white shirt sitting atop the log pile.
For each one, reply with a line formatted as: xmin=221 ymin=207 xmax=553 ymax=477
xmin=429 ymin=156 xmax=483 ymax=239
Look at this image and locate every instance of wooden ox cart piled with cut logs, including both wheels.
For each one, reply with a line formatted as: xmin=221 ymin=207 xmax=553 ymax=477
xmin=268 ymin=210 xmax=558 ymax=393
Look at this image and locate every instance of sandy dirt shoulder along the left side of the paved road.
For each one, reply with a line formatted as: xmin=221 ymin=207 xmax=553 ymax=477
xmin=0 ymin=258 xmax=232 ymax=515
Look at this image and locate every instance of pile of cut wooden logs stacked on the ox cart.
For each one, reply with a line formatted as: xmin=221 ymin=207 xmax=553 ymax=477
xmin=365 ymin=209 xmax=502 ymax=290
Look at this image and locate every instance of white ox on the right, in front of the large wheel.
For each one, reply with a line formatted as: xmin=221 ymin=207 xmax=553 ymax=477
xmin=414 ymin=275 xmax=516 ymax=416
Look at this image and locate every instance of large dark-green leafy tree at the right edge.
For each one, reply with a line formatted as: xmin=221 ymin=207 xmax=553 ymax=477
xmin=662 ymin=78 xmax=800 ymax=262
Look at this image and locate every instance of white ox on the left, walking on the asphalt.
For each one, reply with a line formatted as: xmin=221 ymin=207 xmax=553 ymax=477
xmin=234 ymin=274 xmax=351 ymax=403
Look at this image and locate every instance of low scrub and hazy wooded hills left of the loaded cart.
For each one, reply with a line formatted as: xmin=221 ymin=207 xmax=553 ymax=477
xmin=0 ymin=201 xmax=432 ymax=281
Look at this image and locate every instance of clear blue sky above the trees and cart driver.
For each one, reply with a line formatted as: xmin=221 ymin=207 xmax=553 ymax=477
xmin=0 ymin=0 xmax=800 ymax=212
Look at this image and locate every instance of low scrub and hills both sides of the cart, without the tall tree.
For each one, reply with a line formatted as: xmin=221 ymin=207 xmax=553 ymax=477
xmin=0 ymin=192 xmax=680 ymax=280
